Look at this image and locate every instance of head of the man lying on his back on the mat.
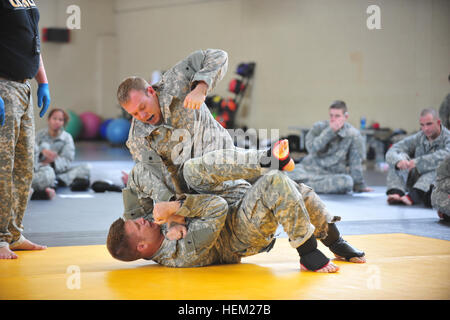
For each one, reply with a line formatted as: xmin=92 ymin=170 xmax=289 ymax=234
xmin=106 ymin=218 xmax=164 ymax=261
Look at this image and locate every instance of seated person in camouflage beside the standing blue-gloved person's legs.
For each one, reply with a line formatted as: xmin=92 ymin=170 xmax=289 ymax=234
xmin=31 ymin=109 xmax=90 ymax=200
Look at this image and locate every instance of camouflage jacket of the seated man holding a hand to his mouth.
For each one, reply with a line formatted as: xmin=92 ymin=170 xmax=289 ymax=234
xmin=300 ymin=121 xmax=365 ymax=189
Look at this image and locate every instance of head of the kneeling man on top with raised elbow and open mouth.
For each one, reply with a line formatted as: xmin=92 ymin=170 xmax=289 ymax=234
xmin=117 ymin=77 xmax=163 ymax=125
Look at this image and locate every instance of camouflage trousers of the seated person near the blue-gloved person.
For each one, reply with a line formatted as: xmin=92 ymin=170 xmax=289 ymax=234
xmin=32 ymin=164 xmax=91 ymax=190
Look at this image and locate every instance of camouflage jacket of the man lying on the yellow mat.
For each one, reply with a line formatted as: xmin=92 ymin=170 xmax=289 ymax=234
xmin=149 ymin=171 xmax=265 ymax=267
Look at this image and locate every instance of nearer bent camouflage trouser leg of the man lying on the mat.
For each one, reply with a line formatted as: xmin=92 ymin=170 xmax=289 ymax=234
xmin=229 ymin=170 xmax=314 ymax=256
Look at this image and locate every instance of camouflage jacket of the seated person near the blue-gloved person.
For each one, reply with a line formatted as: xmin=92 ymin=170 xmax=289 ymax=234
xmin=35 ymin=128 xmax=75 ymax=173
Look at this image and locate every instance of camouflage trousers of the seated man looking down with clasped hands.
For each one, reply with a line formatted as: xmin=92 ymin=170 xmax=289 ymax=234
xmin=386 ymin=166 xmax=436 ymax=193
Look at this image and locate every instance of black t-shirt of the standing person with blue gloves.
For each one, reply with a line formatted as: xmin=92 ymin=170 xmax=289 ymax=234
xmin=0 ymin=0 xmax=40 ymax=80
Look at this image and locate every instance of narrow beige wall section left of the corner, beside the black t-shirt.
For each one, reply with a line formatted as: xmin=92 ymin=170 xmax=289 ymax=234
xmin=34 ymin=0 xmax=120 ymax=128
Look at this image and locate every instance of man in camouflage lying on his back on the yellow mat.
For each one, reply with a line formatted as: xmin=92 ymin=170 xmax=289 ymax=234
xmin=107 ymin=145 xmax=365 ymax=272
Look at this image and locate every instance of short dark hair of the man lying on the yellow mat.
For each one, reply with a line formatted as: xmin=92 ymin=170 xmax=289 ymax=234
xmin=106 ymin=218 xmax=141 ymax=261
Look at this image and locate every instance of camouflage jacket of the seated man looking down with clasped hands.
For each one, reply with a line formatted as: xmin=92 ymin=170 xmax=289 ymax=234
xmin=386 ymin=126 xmax=450 ymax=174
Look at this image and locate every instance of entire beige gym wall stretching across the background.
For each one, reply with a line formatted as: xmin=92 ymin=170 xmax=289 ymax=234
xmin=38 ymin=0 xmax=450 ymax=134
